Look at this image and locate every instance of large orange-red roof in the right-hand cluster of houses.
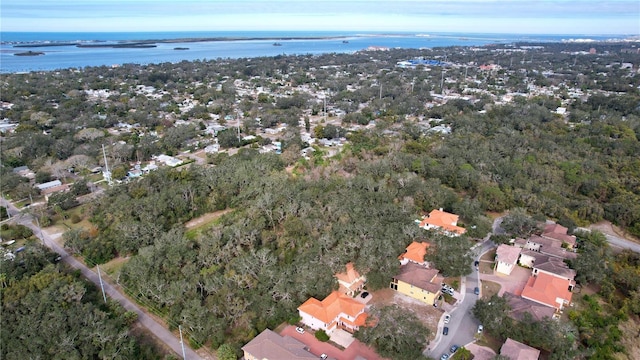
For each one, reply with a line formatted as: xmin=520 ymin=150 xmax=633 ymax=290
xmin=522 ymin=273 xmax=574 ymax=309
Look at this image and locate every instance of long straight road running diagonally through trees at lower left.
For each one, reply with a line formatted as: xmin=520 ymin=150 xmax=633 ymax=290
xmin=0 ymin=198 xmax=202 ymax=359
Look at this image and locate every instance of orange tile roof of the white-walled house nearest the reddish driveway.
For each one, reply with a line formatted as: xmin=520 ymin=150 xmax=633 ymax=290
xmin=298 ymin=291 xmax=365 ymax=324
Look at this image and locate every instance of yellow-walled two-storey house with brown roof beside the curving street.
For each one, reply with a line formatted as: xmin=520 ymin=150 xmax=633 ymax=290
xmin=390 ymin=262 xmax=443 ymax=305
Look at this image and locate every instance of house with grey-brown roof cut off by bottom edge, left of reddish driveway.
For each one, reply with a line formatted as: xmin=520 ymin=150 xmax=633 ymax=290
xmin=242 ymin=329 xmax=318 ymax=360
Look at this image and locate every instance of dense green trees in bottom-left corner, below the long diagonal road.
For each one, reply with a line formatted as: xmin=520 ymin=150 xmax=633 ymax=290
xmin=0 ymin=243 xmax=164 ymax=360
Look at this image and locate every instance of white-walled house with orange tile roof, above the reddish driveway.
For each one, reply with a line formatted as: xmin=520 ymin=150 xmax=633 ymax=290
xmin=298 ymin=291 xmax=367 ymax=334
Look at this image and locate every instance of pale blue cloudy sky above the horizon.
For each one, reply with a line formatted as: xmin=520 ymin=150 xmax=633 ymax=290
xmin=0 ymin=0 xmax=640 ymax=35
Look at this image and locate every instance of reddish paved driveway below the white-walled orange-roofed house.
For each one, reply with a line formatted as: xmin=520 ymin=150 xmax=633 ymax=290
xmin=280 ymin=326 xmax=384 ymax=360
